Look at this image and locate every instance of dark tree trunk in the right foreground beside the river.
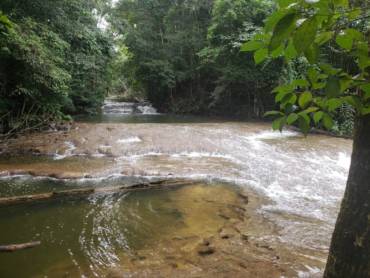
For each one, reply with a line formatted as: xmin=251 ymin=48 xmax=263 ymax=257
xmin=324 ymin=115 xmax=370 ymax=278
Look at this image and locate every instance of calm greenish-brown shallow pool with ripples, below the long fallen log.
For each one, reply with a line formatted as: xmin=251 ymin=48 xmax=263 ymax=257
xmin=0 ymin=183 xmax=240 ymax=277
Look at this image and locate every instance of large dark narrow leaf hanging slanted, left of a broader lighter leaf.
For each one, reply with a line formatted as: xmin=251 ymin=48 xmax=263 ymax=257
xmin=269 ymin=13 xmax=297 ymax=52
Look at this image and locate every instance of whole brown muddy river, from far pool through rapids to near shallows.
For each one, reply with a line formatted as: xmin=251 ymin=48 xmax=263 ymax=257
xmin=0 ymin=105 xmax=352 ymax=277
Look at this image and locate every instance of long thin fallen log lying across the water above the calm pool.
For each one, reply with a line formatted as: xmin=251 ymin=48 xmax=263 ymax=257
xmin=0 ymin=180 xmax=197 ymax=207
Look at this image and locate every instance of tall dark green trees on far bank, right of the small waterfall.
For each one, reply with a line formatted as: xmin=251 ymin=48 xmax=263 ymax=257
xmin=111 ymin=0 xmax=286 ymax=117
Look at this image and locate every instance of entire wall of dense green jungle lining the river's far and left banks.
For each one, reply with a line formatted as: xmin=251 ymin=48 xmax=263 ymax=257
xmin=0 ymin=0 xmax=368 ymax=134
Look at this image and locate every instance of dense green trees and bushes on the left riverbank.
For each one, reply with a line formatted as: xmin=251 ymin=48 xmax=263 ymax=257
xmin=0 ymin=0 xmax=112 ymax=133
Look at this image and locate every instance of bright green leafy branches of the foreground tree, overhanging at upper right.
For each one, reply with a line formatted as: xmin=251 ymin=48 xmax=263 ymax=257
xmin=242 ymin=0 xmax=370 ymax=132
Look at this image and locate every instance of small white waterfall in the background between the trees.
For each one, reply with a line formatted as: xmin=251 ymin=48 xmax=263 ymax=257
xmin=102 ymin=100 xmax=158 ymax=115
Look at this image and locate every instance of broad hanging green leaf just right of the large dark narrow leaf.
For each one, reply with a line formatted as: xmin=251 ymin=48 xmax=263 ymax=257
xmin=293 ymin=17 xmax=317 ymax=53
